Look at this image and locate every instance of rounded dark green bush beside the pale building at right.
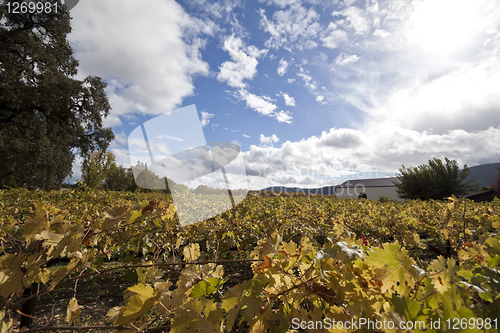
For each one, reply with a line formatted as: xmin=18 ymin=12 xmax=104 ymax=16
xmin=395 ymin=158 xmax=476 ymax=200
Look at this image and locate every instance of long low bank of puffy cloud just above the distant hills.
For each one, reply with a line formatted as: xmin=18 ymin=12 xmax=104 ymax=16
xmin=244 ymin=123 xmax=500 ymax=189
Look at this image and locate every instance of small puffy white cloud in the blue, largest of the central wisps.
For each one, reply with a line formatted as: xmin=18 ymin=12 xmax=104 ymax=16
xmin=217 ymin=35 xmax=267 ymax=88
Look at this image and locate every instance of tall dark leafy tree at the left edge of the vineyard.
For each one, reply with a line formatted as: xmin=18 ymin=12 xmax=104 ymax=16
xmin=0 ymin=0 xmax=114 ymax=189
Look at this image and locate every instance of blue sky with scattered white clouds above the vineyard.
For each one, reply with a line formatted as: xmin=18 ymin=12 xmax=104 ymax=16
xmin=69 ymin=0 xmax=500 ymax=189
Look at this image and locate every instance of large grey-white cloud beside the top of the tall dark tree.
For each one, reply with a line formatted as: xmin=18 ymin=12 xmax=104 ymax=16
xmin=68 ymin=0 xmax=214 ymax=119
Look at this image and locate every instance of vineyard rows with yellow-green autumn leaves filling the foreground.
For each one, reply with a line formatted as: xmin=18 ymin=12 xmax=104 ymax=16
xmin=0 ymin=189 xmax=500 ymax=332
